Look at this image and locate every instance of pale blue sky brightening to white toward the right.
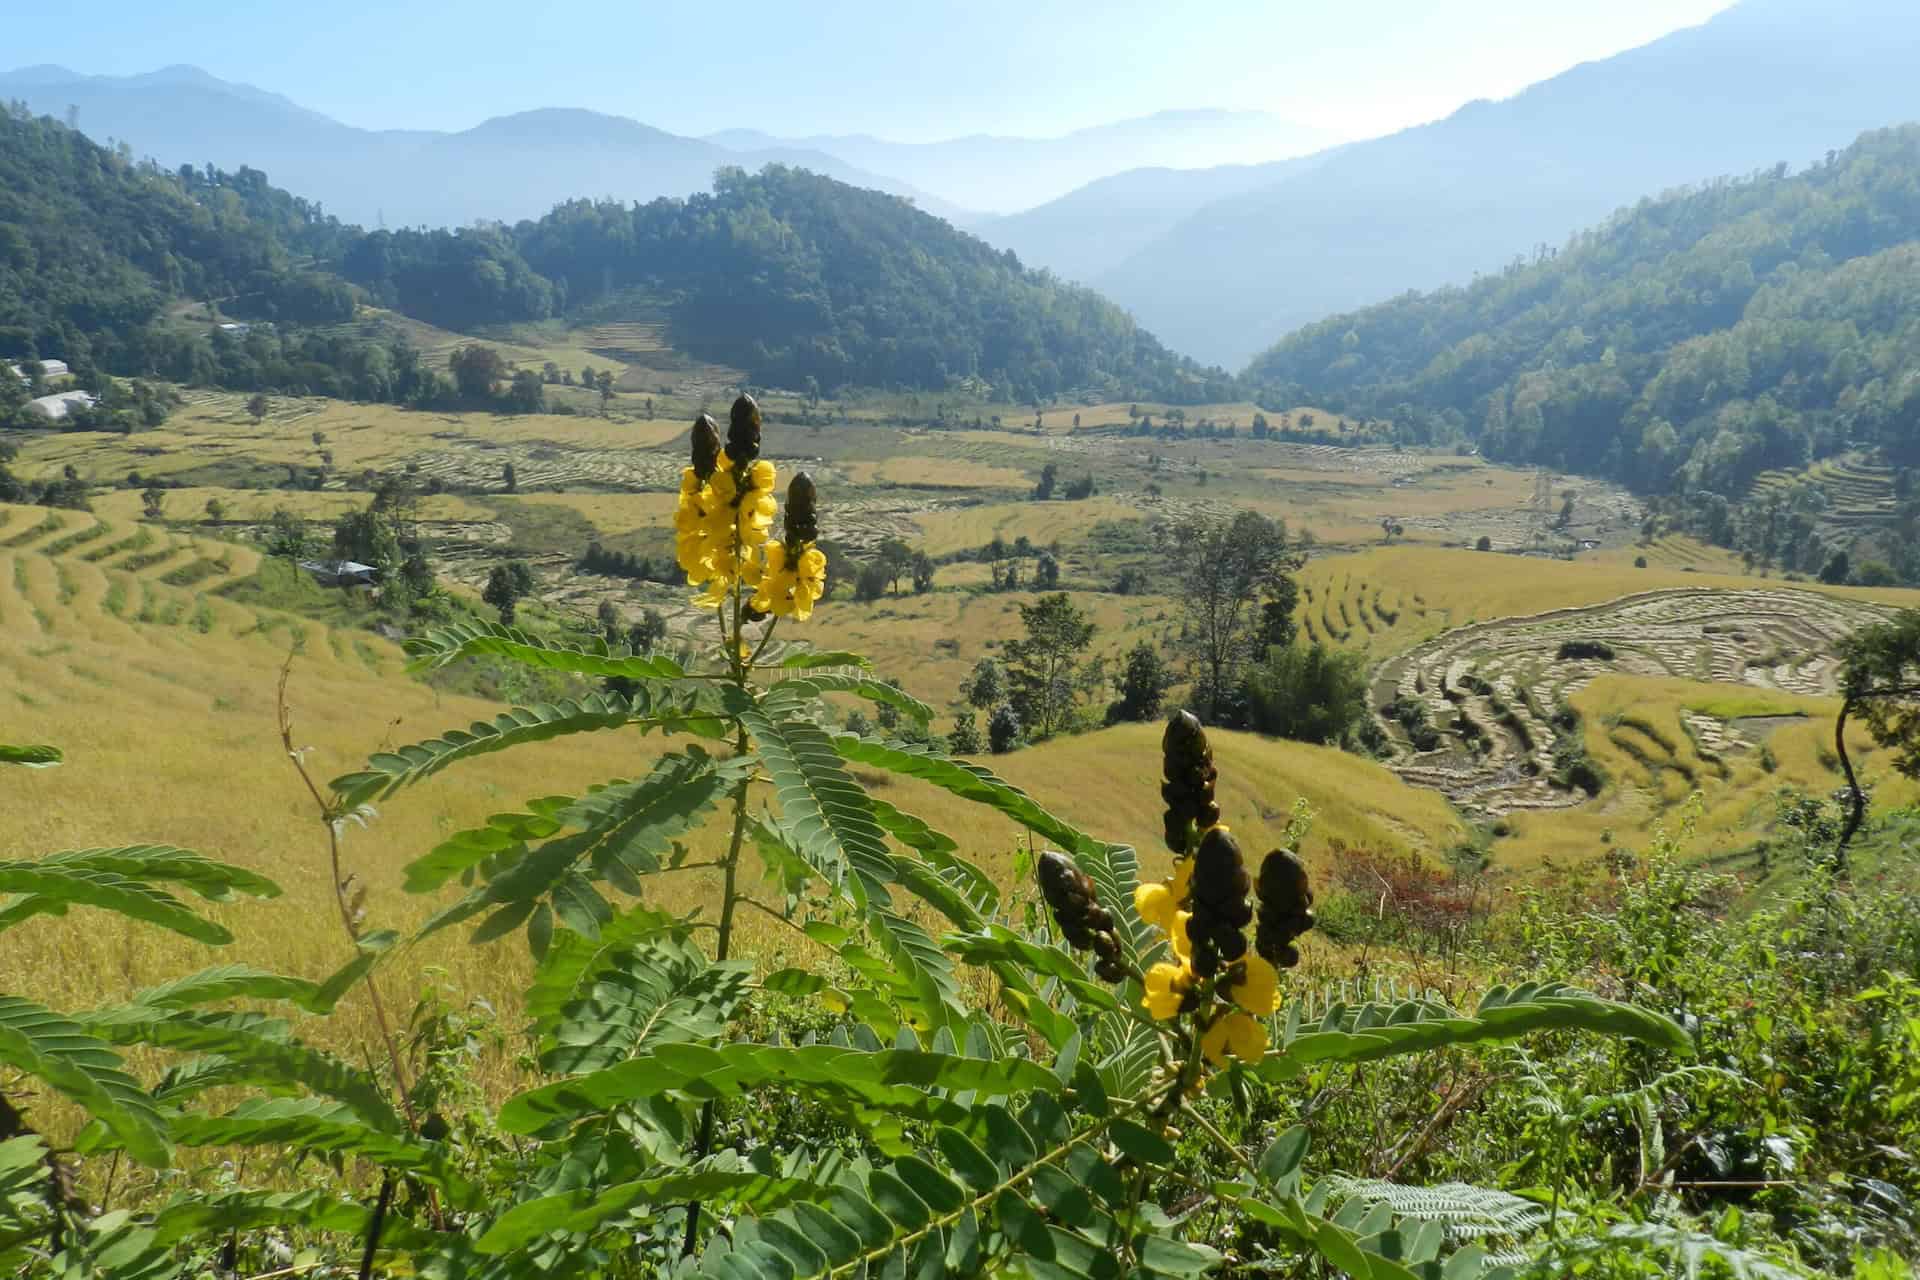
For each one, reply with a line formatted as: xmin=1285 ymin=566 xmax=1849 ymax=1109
xmin=18 ymin=0 xmax=1730 ymax=140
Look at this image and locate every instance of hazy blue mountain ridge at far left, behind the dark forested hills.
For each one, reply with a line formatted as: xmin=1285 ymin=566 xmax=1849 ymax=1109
xmin=0 ymin=67 xmax=964 ymax=226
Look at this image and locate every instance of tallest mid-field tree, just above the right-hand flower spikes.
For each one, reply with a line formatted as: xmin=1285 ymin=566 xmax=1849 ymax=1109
xmin=1171 ymin=510 xmax=1294 ymax=723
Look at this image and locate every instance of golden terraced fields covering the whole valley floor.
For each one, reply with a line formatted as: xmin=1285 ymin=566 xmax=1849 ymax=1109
xmin=0 ymin=379 xmax=1920 ymax=992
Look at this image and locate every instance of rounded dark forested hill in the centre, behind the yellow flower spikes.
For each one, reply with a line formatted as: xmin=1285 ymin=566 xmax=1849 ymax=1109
xmin=515 ymin=165 xmax=1231 ymax=401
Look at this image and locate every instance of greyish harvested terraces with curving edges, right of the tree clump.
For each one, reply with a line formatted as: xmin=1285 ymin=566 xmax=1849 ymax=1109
xmin=1373 ymin=589 xmax=1889 ymax=814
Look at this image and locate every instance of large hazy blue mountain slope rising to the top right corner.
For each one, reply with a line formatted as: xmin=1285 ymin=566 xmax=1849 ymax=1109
xmin=1091 ymin=0 xmax=1920 ymax=365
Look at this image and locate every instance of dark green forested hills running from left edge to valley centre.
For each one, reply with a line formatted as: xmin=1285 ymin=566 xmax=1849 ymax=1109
xmin=0 ymin=109 xmax=1233 ymax=401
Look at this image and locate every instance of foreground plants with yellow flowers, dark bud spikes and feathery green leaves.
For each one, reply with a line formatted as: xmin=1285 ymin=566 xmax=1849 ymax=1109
xmin=0 ymin=397 xmax=1688 ymax=1280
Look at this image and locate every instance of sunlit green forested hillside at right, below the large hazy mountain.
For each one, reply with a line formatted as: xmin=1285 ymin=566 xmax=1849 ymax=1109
xmin=1246 ymin=127 xmax=1920 ymax=495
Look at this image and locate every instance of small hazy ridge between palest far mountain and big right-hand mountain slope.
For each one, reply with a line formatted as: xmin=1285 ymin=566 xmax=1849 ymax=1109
xmin=970 ymin=152 xmax=1332 ymax=282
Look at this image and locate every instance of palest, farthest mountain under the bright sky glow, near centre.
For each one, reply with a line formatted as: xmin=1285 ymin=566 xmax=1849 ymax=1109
xmin=707 ymin=109 xmax=1334 ymax=213
